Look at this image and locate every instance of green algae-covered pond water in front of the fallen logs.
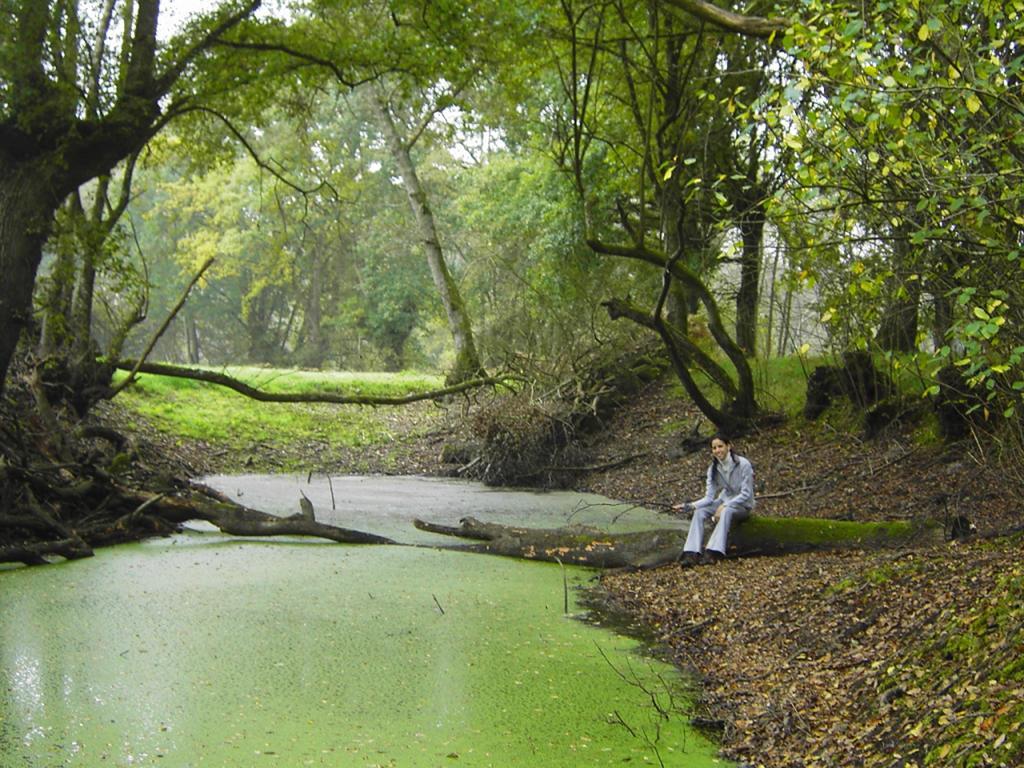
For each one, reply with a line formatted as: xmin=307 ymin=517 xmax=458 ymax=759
xmin=0 ymin=479 xmax=724 ymax=768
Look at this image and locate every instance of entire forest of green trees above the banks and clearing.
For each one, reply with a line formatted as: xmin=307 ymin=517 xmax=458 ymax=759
xmin=0 ymin=0 xmax=1024 ymax=439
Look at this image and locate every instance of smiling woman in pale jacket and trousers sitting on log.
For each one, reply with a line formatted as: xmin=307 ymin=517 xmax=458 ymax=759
xmin=673 ymin=433 xmax=754 ymax=563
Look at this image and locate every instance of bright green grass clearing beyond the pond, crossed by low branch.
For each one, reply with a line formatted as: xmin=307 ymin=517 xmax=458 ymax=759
xmin=119 ymin=367 xmax=443 ymax=456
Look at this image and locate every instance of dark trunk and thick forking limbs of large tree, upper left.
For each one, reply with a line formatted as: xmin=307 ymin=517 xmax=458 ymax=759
xmin=0 ymin=0 xmax=259 ymax=387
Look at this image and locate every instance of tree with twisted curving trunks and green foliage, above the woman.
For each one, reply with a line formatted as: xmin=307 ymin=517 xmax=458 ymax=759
xmin=540 ymin=1 xmax=772 ymax=428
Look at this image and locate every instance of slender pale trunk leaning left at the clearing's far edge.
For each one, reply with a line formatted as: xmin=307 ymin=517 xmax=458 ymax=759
xmin=374 ymin=96 xmax=484 ymax=384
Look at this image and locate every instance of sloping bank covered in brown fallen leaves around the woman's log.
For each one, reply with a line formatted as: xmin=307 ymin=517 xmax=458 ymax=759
xmin=581 ymin=385 xmax=1024 ymax=768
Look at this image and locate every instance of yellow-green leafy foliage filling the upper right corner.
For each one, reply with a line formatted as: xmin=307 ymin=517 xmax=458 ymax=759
xmin=764 ymin=2 xmax=1024 ymax=423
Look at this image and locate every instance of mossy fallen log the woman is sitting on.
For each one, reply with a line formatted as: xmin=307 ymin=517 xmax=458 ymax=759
xmin=414 ymin=516 xmax=942 ymax=568
